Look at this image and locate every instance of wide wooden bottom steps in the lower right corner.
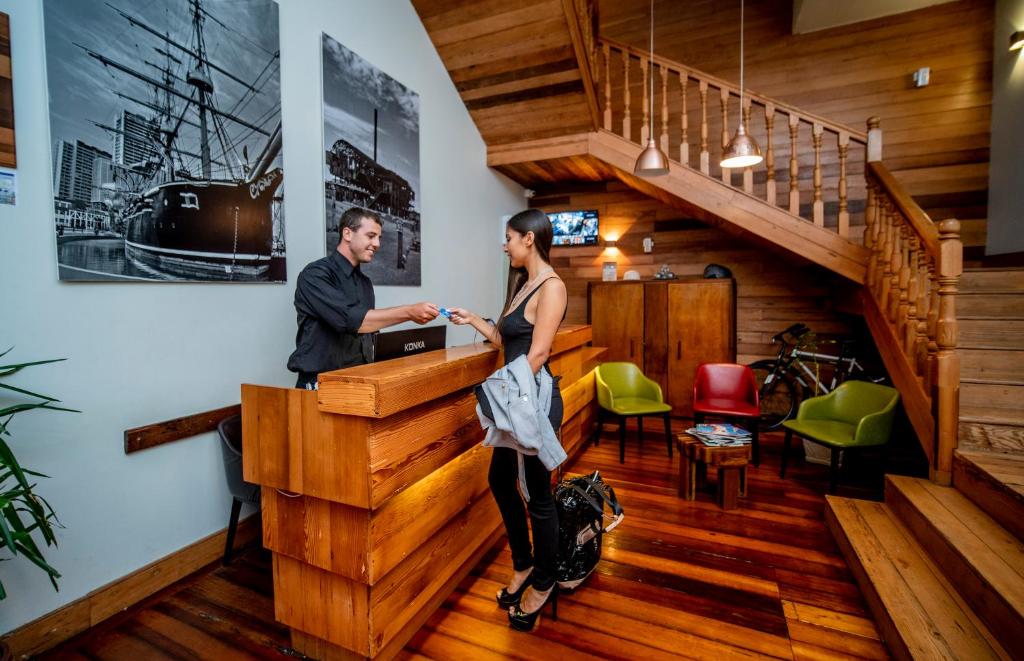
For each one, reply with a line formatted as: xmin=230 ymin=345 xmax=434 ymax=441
xmin=825 ymin=474 xmax=1024 ymax=660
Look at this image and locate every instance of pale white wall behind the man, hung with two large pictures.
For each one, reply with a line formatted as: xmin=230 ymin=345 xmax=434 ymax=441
xmin=0 ymin=0 xmax=525 ymax=631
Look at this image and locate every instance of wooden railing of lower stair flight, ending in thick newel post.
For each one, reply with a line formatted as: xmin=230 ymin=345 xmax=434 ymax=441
xmin=864 ymin=129 xmax=964 ymax=484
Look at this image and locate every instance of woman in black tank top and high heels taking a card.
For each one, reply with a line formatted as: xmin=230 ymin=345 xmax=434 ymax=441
xmin=451 ymin=209 xmax=566 ymax=630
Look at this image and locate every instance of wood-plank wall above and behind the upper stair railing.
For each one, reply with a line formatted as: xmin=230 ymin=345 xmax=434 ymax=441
xmin=599 ymin=0 xmax=992 ymax=253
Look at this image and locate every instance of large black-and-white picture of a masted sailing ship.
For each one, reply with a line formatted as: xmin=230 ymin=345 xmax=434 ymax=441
xmin=43 ymin=0 xmax=286 ymax=282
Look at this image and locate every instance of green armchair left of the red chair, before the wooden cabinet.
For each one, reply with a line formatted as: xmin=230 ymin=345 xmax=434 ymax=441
xmin=592 ymin=362 xmax=672 ymax=464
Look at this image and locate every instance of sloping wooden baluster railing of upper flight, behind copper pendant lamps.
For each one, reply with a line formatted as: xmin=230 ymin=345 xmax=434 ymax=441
xmin=597 ymin=38 xmax=867 ymax=238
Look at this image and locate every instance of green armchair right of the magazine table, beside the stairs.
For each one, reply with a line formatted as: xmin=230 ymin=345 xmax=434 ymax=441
xmin=778 ymin=381 xmax=899 ymax=493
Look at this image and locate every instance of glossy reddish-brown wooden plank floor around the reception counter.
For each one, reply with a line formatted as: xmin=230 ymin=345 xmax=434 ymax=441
xmin=44 ymin=429 xmax=887 ymax=661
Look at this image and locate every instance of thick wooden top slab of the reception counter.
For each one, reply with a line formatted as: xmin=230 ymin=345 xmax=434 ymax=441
xmin=317 ymin=325 xmax=591 ymax=417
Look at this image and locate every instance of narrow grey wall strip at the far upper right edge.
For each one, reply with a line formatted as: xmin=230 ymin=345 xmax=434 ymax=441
xmin=985 ymin=0 xmax=1024 ymax=255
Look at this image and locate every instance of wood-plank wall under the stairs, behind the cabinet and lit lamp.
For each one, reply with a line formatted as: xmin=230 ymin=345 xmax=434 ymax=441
xmin=531 ymin=182 xmax=852 ymax=363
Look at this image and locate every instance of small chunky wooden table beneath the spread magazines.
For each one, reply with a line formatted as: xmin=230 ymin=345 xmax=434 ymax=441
xmin=676 ymin=433 xmax=751 ymax=510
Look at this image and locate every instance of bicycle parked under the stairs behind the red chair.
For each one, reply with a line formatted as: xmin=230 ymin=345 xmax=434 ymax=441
xmin=748 ymin=323 xmax=886 ymax=430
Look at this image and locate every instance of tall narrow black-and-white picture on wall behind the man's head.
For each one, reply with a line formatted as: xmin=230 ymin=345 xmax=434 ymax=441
xmin=322 ymin=35 xmax=421 ymax=287
